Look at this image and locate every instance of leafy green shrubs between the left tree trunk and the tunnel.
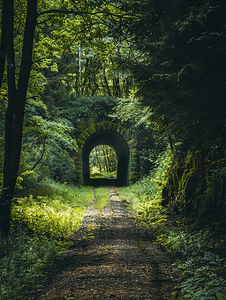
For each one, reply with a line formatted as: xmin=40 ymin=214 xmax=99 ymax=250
xmin=20 ymin=97 xmax=77 ymax=184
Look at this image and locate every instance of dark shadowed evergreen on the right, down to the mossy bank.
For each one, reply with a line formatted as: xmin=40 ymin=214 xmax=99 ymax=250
xmin=115 ymin=0 xmax=226 ymax=229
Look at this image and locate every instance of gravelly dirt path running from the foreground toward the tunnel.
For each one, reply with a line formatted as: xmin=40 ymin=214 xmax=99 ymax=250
xmin=39 ymin=191 xmax=178 ymax=300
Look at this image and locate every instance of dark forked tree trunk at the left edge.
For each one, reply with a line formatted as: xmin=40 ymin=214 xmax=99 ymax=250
xmin=0 ymin=0 xmax=37 ymax=235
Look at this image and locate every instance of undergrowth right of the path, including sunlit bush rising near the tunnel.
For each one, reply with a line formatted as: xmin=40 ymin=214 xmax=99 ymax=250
xmin=118 ymin=149 xmax=226 ymax=300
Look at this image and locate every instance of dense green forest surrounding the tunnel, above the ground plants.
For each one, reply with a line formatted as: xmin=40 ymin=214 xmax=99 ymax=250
xmin=0 ymin=0 xmax=226 ymax=299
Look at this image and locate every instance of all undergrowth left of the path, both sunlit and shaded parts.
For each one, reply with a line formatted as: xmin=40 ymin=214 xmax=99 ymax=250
xmin=0 ymin=181 xmax=94 ymax=300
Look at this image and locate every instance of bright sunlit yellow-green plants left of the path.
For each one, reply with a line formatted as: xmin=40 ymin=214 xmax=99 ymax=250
xmin=11 ymin=182 xmax=94 ymax=239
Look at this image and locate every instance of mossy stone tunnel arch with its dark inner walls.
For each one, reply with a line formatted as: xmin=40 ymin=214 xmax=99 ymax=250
xmin=76 ymin=121 xmax=139 ymax=186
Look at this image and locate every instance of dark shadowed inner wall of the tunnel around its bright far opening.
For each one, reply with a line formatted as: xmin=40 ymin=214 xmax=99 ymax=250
xmin=82 ymin=131 xmax=130 ymax=186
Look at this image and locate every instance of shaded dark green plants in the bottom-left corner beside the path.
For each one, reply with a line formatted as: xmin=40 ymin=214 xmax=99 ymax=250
xmin=0 ymin=231 xmax=60 ymax=300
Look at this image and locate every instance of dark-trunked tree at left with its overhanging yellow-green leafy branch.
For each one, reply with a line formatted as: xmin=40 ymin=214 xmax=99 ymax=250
xmin=0 ymin=0 xmax=136 ymax=234
